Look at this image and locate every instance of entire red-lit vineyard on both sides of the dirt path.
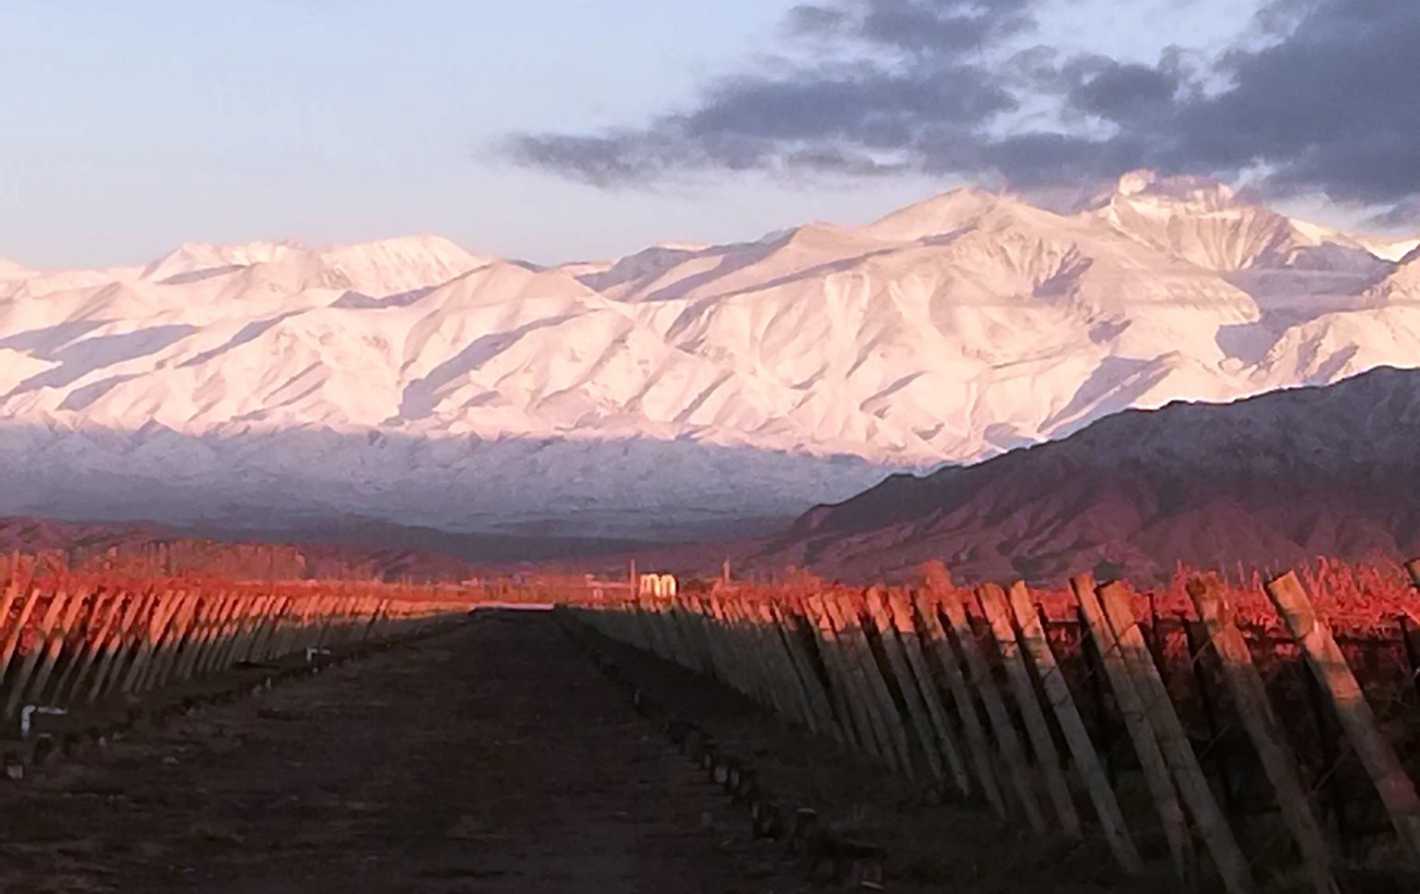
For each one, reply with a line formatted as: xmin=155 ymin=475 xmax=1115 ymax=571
xmin=11 ymin=555 xmax=1420 ymax=894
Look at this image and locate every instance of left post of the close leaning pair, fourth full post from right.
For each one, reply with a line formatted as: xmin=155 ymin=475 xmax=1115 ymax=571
xmin=1071 ymin=575 xmax=1193 ymax=881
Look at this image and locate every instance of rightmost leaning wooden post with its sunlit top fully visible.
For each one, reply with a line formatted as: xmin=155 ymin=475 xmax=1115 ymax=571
xmin=1267 ymin=572 xmax=1420 ymax=857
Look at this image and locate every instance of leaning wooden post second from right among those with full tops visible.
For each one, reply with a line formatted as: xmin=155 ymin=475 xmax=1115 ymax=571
xmin=1187 ymin=579 xmax=1336 ymax=894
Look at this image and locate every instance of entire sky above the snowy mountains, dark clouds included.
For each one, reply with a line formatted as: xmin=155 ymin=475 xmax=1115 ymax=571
xmin=0 ymin=0 xmax=1420 ymax=267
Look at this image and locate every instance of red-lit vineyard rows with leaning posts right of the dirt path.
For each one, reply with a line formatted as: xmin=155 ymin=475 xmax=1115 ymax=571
xmin=569 ymin=562 xmax=1420 ymax=893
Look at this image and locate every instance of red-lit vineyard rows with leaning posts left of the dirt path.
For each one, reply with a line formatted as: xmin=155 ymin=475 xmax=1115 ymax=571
xmin=0 ymin=555 xmax=486 ymax=775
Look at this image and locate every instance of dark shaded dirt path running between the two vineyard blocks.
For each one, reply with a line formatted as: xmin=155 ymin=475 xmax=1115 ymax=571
xmin=0 ymin=614 xmax=801 ymax=894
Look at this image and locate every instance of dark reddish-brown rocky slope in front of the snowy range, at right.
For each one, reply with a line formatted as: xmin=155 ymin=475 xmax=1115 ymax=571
xmin=747 ymin=368 xmax=1420 ymax=580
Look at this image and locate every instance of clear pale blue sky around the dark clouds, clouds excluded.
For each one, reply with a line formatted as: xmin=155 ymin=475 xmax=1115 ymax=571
xmin=0 ymin=0 xmax=1397 ymax=267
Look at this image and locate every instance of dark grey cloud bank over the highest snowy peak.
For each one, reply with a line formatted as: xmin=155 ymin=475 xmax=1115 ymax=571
xmin=508 ymin=0 xmax=1420 ymax=220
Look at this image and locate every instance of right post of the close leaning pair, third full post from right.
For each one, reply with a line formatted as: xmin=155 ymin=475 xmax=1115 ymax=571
xmin=1099 ymin=583 xmax=1252 ymax=894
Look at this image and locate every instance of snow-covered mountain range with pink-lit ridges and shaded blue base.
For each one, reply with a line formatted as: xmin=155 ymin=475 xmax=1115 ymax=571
xmin=0 ymin=173 xmax=1420 ymax=536
